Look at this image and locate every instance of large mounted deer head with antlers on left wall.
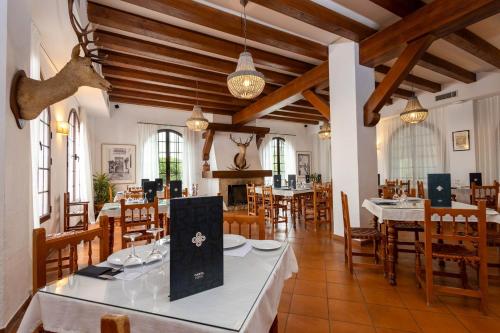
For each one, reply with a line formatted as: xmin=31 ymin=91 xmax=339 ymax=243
xmin=10 ymin=0 xmax=111 ymax=128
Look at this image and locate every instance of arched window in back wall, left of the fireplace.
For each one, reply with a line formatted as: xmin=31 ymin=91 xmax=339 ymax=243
xmin=158 ymin=129 xmax=184 ymax=183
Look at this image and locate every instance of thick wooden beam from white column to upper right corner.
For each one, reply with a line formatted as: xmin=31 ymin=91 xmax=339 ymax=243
xmin=359 ymin=0 xmax=500 ymax=67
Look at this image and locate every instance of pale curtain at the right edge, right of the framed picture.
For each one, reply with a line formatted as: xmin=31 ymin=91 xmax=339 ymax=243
xmin=474 ymin=96 xmax=500 ymax=184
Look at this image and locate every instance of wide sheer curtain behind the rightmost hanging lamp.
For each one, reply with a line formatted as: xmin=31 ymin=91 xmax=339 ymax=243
xmin=377 ymin=108 xmax=447 ymax=182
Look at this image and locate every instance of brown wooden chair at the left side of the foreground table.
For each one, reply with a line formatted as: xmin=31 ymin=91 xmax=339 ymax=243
xmin=32 ymin=216 xmax=109 ymax=292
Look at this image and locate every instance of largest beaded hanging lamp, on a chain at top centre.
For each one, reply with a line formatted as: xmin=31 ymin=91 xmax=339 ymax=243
xmin=227 ymin=0 xmax=266 ymax=99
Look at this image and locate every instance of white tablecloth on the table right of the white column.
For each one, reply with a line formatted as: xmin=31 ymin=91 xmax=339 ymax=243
xmin=362 ymin=199 xmax=500 ymax=223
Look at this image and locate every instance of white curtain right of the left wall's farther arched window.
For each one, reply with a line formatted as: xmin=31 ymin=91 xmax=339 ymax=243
xmin=78 ymin=111 xmax=95 ymax=223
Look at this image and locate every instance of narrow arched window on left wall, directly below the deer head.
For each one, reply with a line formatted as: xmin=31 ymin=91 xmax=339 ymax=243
xmin=38 ymin=108 xmax=52 ymax=223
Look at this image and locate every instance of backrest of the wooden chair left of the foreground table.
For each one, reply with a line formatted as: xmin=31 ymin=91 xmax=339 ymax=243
xmin=33 ymin=215 xmax=109 ymax=292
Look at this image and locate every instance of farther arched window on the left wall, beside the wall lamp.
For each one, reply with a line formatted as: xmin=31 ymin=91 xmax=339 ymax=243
xmin=67 ymin=109 xmax=80 ymax=201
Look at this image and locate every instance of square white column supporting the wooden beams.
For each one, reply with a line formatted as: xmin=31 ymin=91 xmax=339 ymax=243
xmin=328 ymin=41 xmax=377 ymax=236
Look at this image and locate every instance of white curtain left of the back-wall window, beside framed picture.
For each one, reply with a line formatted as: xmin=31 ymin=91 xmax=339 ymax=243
xmin=137 ymin=124 xmax=160 ymax=182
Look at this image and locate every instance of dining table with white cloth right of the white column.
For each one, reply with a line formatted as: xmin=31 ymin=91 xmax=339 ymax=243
xmin=362 ymin=198 xmax=500 ymax=285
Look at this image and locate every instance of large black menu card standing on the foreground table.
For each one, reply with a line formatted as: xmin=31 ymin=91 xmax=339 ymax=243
xmin=170 ymin=196 xmax=224 ymax=301
